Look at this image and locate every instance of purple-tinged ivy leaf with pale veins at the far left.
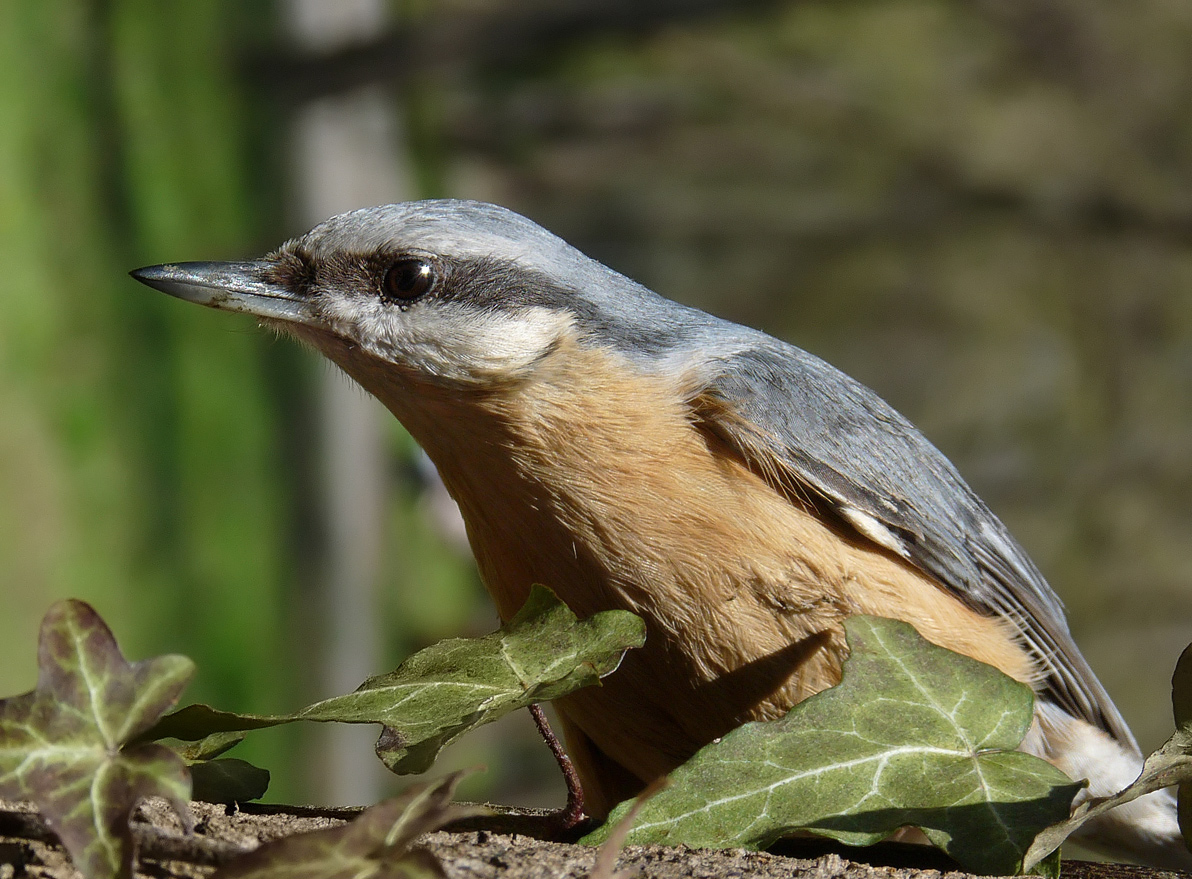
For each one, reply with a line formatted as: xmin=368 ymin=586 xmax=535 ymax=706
xmin=0 ymin=601 xmax=194 ymax=879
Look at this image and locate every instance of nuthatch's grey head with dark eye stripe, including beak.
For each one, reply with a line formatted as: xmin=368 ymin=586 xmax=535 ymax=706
xmin=132 ymin=200 xmax=708 ymax=386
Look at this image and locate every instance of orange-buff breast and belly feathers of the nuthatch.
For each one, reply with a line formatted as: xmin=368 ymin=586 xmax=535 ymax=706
xmin=345 ymin=351 xmax=1030 ymax=801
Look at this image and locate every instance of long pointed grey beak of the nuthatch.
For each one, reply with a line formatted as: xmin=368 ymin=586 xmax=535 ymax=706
xmin=129 ymin=260 xmax=316 ymax=324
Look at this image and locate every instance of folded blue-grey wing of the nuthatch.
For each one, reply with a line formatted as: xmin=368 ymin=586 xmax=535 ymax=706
xmin=696 ymin=336 xmax=1137 ymax=747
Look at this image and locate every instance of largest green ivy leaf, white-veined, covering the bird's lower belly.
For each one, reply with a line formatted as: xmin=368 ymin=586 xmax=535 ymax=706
xmin=584 ymin=617 xmax=1080 ymax=874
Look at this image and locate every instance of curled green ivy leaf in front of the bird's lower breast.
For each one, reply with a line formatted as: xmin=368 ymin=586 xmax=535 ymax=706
xmin=145 ymin=586 xmax=645 ymax=774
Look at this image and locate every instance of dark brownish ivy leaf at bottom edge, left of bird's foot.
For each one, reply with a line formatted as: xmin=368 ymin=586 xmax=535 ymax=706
xmin=212 ymin=773 xmax=486 ymax=879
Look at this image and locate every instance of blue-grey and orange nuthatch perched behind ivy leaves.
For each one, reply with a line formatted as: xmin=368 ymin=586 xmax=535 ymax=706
xmin=131 ymin=199 xmax=1192 ymax=868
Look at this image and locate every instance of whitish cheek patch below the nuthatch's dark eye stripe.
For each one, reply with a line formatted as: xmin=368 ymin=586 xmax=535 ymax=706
xmin=324 ymin=301 xmax=573 ymax=382
